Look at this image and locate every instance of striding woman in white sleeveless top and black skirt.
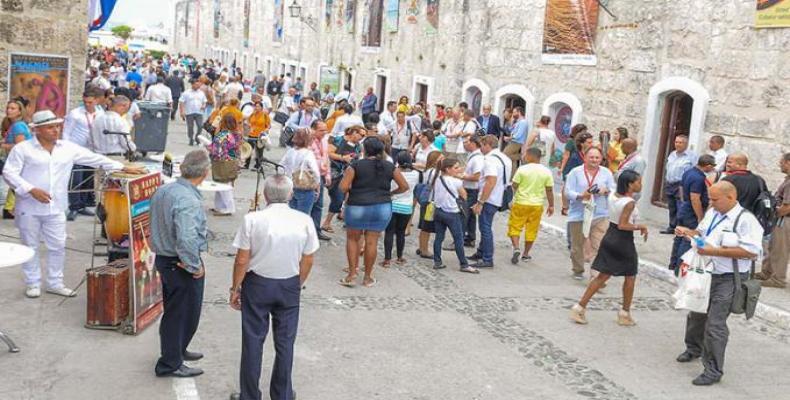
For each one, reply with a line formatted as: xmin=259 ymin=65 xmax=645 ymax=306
xmin=571 ymin=171 xmax=647 ymax=326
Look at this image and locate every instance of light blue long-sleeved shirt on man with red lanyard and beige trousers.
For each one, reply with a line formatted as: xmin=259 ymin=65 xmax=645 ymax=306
xmin=565 ymin=165 xmax=617 ymax=222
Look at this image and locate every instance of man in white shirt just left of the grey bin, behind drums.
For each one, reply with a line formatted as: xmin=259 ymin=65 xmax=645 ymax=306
xmin=88 ymin=96 xmax=137 ymax=161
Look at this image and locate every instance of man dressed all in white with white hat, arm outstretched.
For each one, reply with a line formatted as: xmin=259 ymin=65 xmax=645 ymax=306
xmin=3 ymin=110 xmax=144 ymax=298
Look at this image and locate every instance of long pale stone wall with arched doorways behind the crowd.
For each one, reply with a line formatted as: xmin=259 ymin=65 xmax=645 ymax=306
xmin=175 ymin=0 xmax=790 ymax=197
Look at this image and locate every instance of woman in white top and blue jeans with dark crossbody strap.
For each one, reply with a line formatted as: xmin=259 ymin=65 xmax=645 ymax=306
xmin=433 ymin=158 xmax=480 ymax=274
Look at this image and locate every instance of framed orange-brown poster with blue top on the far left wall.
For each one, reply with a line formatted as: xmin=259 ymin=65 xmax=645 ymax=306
xmin=8 ymin=53 xmax=70 ymax=117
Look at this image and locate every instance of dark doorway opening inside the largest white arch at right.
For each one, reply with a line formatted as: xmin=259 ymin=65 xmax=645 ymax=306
xmin=650 ymin=90 xmax=694 ymax=207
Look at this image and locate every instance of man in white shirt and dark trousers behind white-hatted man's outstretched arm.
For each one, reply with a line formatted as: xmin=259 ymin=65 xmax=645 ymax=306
xmin=63 ymin=86 xmax=104 ymax=221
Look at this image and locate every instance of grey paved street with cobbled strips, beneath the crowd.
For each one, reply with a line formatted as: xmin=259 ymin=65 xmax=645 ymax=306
xmin=0 ymin=117 xmax=790 ymax=400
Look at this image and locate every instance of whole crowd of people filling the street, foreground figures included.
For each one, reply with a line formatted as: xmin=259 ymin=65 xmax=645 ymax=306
xmin=2 ymin=49 xmax=790 ymax=399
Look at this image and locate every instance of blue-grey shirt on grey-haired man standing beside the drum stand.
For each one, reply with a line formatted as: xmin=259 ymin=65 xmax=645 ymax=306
xmin=151 ymin=178 xmax=208 ymax=274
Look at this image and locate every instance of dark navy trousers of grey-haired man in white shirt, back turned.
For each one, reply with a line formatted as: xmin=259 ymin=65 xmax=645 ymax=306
xmin=239 ymin=272 xmax=302 ymax=400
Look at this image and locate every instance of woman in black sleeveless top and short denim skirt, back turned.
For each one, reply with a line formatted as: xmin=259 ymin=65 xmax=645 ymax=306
xmin=340 ymin=136 xmax=409 ymax=287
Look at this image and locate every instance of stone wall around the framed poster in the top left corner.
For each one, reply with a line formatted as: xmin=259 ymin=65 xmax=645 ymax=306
xmin=0 ymin=0 xmax=88 ymax=114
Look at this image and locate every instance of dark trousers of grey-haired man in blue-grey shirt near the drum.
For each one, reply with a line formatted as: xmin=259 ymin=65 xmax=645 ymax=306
xmin=155 ymin=255 xmax=205 ymax=374
